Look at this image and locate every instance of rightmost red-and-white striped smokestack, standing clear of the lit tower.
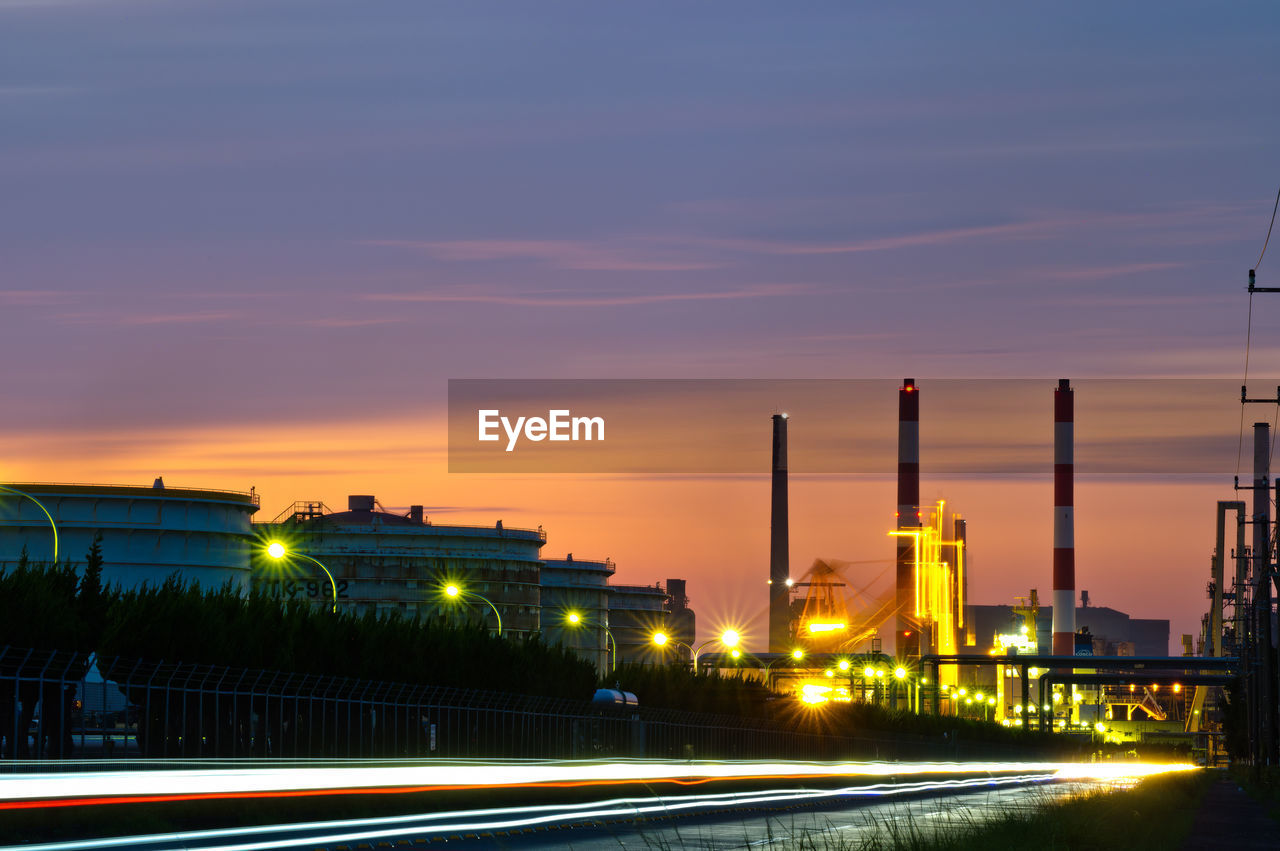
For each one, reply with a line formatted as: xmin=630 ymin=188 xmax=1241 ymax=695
xmin=1053 ymin=379 xmax=1075 ymax=656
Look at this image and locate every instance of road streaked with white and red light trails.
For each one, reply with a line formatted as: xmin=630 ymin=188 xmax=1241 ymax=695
xmin=0 ymin=761 xmax=1187 ymax=851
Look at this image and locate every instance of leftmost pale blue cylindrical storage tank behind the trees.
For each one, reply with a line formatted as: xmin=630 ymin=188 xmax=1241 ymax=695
xmin=0 ymin=479 xmax=259 ymax=589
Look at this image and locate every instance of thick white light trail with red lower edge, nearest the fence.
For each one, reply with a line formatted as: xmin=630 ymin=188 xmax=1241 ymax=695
xmin=0 ymin=761 xmax=1175 ymax=810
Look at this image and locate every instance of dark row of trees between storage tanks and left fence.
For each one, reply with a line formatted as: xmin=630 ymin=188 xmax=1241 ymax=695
xmin=0 ymin=543 xmax=595 ymax=700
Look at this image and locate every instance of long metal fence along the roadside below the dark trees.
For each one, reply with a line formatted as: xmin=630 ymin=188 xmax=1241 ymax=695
xmin=0 ymin=648 xmax=1039 ymax=760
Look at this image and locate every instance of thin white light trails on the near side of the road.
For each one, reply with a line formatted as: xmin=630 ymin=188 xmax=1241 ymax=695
xmin=5 ymin=772 xmax=1056 ymax=851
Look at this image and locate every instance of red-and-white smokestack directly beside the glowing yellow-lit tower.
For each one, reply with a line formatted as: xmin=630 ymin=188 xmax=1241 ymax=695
xmin=893 ymin=379 xmax=920 ymax=656
